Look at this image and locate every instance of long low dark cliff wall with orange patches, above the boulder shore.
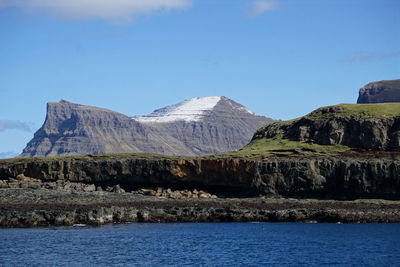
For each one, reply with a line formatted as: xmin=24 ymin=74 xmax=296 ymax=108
xmin=0 ymin=153 xmax=400 ymax=199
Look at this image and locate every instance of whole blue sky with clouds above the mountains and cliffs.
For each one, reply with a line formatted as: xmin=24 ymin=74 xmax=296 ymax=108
xmin=0 ymin=0 xmax=400 ymax=158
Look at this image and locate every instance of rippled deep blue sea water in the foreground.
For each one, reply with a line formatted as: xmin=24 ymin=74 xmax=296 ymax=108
xmin=0 ymin=223 xmax=400 ymax=266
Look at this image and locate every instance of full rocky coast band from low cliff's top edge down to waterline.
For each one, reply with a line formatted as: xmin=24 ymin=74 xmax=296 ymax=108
xmin=0 ymin=153 xmax=400 ymax=227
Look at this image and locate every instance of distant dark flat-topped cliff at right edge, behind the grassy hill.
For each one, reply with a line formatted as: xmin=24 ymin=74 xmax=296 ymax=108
xmin=357 ymin=79 xmax=400 ymax=104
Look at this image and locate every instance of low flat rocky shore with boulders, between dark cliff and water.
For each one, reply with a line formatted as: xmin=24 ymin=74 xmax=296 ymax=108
xmin=0 ymin=182 xmax=400 ymax=227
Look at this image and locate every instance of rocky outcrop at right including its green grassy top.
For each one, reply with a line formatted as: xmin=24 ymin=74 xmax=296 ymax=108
xmin=253 ymin=104 xmax=400 ymax=151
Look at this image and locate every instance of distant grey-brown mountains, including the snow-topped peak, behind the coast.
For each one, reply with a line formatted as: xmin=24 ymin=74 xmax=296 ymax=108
xmin=21 ymin=96 xmax=273 ymax=157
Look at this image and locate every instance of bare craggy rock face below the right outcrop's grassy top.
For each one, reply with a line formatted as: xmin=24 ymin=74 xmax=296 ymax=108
xmin=253 ymin=111 xmax=400 ymax=151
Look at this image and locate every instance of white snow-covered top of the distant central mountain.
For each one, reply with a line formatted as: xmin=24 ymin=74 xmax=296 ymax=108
xmin=133 ymin=96 xmax=254 ymax=123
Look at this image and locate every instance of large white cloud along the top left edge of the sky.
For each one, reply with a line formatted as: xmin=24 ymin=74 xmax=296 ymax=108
xmin=0 ymin=0 xmax=191 ymax=22
